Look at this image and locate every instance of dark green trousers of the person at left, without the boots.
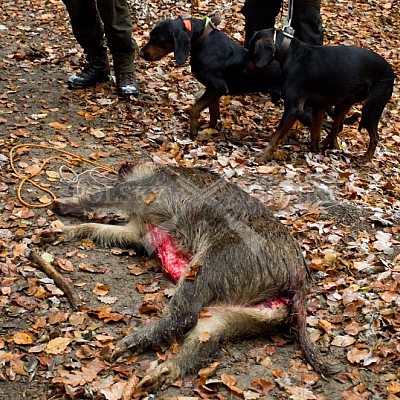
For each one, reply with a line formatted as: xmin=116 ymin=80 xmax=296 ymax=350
xmin=62 ymin=0 xmax=136 ymax=72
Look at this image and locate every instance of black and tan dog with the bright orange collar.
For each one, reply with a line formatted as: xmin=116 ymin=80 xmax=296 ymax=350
xmin=140 ymin=18 xmax=281 ymax=139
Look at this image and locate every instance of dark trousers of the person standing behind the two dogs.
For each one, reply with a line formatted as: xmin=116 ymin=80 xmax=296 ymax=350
xmin=242 ymin=0 xmax=324 ymax=45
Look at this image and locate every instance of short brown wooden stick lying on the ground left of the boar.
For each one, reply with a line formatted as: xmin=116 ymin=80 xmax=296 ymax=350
xmin=25 ymin=247 xmax=82 ymax=310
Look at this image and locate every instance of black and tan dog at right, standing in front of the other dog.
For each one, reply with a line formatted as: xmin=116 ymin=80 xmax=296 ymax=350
xmin=248 ymin=29 xmax=394 ymax=161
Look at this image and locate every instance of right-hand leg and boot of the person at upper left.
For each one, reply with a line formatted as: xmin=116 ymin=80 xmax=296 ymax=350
xmin=97 ymin=0 xmax=139 ymax=95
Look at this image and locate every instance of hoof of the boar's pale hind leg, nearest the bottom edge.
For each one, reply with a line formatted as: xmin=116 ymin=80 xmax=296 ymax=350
xmin=136 ymin=361 xmax=181 ymax=393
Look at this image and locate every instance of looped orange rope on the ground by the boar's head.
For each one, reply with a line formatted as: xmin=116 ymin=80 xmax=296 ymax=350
xmin=9 ymin=143 xmax=118 ymax=208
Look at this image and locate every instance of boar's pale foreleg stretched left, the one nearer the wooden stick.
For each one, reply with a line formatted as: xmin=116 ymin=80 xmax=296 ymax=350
xmin=41 ymin=221 xmax=143 ymax=247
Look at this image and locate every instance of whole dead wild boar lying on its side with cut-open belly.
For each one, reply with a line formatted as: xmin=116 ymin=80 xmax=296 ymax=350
xmin=42 ymin=159 xmax=330 ymax=391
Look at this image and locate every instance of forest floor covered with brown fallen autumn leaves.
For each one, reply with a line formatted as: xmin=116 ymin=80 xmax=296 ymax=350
xmin=0 ymin=0 xmax=400 ymax=400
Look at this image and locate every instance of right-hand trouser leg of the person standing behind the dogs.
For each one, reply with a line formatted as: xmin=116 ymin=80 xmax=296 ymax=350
xmin=292 ymin=0 xmax=324 ymax=46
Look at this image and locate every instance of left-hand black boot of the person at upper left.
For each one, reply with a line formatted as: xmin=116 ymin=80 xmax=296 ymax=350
xmin=68 ymin=54 xmax=110 ymax=89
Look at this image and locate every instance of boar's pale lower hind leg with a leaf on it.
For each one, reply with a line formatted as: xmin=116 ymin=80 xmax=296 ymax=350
xmin=137 ymin=304 xmax=289 ymax=392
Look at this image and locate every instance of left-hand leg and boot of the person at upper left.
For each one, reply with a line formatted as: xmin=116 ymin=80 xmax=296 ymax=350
xmin=63 ymin=0 xmax=110 ymax=89
